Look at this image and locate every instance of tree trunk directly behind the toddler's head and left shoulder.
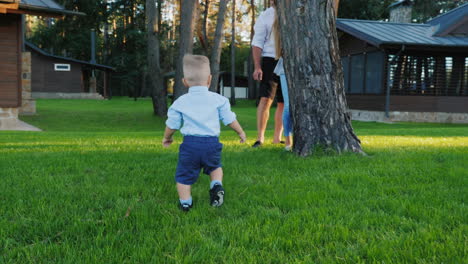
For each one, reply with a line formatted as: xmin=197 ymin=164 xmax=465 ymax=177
xmin=174 ymin=0 xmax=198 ymax=100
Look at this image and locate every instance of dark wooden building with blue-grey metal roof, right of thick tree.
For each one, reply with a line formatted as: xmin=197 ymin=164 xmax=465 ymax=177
xmin=337 ymin=1 xmax=468 ymax=123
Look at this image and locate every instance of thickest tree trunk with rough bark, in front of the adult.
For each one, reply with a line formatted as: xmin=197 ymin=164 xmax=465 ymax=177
xmin=278 ymin=0 xmax=363 ymax=156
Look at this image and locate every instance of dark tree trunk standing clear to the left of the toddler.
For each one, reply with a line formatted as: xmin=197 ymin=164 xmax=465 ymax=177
xmin=146 ymin=0 xmax=167 ymax=116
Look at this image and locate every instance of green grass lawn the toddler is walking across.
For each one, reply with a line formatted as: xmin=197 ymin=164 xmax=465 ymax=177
xmin=0 ymin=98 xmax=468 ymax=263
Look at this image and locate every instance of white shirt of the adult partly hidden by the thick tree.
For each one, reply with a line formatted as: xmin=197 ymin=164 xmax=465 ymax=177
xmin=252 ymin=7 xmax=276 ymax=58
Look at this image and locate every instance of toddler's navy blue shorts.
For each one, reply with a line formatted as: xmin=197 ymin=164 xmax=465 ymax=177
xmin=175 ymin=136 xmax=223 ymax=185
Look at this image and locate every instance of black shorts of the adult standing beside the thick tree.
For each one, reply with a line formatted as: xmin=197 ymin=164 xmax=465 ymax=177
xmin=260 ymin=57 xmax=284 ymax=103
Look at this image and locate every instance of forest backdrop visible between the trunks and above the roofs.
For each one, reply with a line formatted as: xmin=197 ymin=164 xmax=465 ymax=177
xmin=26 ymin=0 xmax=466 ymax=97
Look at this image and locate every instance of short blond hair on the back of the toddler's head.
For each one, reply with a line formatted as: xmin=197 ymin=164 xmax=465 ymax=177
xmin=184 ymin=54 xmax=211 ymax=86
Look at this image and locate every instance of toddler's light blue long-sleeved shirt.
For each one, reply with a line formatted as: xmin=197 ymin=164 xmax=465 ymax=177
xmin=166 ymin=86 xmax=236 ymax=137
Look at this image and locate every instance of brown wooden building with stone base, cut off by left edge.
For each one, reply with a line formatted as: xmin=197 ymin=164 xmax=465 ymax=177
xmin=0 ymin=0 xmax=84 ymax=130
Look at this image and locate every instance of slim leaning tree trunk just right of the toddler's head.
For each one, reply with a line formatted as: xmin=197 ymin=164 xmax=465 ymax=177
xmin=210 ymin=0 xmax=227 ymax=92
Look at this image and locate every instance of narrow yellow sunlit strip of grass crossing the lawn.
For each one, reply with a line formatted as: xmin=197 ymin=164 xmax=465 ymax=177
xmin=0 ymin=135 xmax=468 ymax=153
